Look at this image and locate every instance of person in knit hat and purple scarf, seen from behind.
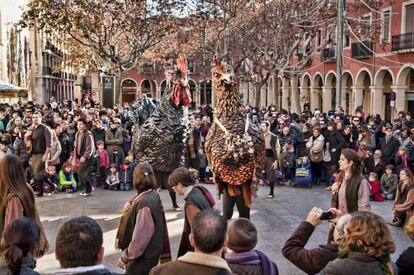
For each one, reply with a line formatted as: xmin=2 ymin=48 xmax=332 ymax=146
xmin=225 ymin=218 xmax=279 ymax=275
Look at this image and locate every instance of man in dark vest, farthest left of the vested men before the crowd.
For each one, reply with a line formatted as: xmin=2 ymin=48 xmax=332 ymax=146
xmin=28 ymin=111 xmax=52 ymax=197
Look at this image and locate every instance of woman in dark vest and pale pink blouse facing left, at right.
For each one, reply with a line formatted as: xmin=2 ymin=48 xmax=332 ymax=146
xmin=332 ymin=149 xmax=371 ymax=216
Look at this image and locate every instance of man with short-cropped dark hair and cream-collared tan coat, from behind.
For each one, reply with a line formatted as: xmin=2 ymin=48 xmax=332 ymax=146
xmin=150 ymin=209 xmax=231 ymax=275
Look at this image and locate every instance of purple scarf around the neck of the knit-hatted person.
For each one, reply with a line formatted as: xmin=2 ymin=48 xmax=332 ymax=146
xmin=224 ymin=250 xmax=279 ymax=275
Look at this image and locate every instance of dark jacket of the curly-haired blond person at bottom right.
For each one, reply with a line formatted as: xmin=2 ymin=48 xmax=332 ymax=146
xmin=320 ymin=252 xmax=397 ymax=275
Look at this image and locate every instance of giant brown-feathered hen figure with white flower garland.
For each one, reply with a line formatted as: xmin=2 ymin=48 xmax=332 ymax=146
xmin=205 ymin=57 xmax=265 ymax=219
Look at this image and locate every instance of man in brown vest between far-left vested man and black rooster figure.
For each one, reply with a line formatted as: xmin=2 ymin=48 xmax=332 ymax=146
xmin=72 ymin=118 xmax=95 ymax=197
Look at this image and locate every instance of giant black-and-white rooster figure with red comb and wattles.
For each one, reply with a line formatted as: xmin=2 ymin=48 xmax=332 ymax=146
xmin=133 ymin=56 xmax=191 ymax=210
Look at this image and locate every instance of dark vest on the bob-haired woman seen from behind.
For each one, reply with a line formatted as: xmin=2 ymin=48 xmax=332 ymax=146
xmin=118 ymin=190 xmax=164 ymax=259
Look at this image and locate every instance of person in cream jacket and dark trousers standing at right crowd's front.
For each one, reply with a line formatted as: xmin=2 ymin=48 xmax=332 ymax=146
xmin=306 ymin=127 xmax=325 ymax=184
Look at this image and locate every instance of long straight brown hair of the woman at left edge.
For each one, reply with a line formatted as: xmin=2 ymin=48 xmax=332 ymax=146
xmin=0 ymin=155 xmax=49 ymax=257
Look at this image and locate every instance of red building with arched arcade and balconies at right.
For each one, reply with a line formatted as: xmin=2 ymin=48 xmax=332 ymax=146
xmin=241 ymin=0 xmax=414 ymax=119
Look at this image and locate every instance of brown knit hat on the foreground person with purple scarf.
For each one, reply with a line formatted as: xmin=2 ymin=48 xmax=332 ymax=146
xmin=227 ymin=218 xmax=257 ymax=253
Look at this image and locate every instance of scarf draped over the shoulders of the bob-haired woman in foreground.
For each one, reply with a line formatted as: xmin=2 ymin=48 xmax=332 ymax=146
xmin=115 ymin=191 xmax=171 ymax=264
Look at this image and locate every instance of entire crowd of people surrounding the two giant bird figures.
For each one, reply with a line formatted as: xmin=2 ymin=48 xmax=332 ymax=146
xmin=0 ymin=97 xmax=414 ymax=275
